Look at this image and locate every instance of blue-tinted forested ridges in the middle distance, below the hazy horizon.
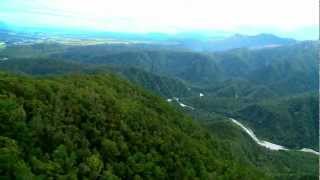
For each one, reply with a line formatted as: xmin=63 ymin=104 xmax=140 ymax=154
xmin=52 ymin=42 xmax=319 ymax=95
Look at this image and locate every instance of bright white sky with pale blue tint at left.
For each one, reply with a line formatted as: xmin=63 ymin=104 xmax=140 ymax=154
xmin=0 ymin=0 xmax=319 ymax=38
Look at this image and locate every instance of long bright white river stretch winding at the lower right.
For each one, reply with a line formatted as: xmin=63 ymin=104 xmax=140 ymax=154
xmin=230 ymin=118 xmax=320 ymax=155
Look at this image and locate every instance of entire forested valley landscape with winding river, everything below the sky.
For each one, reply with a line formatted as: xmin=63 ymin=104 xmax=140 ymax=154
xmin=0 ymin=26 xmax=319 ymax=179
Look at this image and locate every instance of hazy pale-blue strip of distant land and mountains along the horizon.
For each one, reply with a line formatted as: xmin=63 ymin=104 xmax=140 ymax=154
xmin=0 ymin=22 xmax=297 ymax=52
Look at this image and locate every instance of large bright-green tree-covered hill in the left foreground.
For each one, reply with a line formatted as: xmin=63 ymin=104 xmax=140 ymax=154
xmin=0 ymin=73 xmax=266 ymax=179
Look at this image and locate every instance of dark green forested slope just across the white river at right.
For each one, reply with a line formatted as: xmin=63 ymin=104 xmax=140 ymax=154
xmin=182 ymin=90 xmax=319 ymax=150
